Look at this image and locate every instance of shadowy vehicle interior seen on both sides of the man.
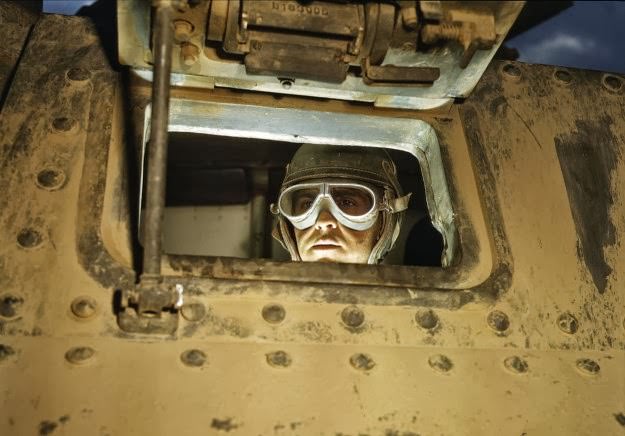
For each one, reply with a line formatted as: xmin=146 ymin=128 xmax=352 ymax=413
xmin=156 ymin=132 xmax=443 ymax=267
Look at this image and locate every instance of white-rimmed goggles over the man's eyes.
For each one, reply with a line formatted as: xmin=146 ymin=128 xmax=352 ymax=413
xmin=273 ymin=182 xmax=380 ymax=231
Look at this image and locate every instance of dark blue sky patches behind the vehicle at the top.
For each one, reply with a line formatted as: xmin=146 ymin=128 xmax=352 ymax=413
xmin=43 ymin=0 xmax=625 ymax=73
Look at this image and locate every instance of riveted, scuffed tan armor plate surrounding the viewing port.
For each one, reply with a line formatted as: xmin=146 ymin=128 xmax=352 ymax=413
xmin=0 ymin=3 xmax=625 ymax=435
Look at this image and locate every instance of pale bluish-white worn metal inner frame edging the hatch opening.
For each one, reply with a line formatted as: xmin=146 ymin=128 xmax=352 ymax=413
xmin=139 ymin=99 xmax=457 ymax=267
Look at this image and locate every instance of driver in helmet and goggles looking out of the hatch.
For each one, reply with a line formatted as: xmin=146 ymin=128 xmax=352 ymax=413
xmin=271 ymin=144 xmax=411 ymax=264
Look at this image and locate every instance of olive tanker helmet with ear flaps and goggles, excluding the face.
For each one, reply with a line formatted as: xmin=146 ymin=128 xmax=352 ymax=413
xmin=271 ymin=144 xmax=411 ymax=264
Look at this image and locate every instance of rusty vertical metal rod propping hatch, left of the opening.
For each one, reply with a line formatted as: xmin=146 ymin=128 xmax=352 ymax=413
xmin=142 ymin=1 xmax=173 ymax=281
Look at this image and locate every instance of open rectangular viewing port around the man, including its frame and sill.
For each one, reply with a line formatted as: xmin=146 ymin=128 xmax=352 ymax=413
xmin=135 ymin=99 xmax=492 ymax=289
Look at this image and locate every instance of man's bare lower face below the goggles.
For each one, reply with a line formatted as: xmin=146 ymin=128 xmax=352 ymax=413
xmin=294 ymin=210 xmax=381 ymax=263
